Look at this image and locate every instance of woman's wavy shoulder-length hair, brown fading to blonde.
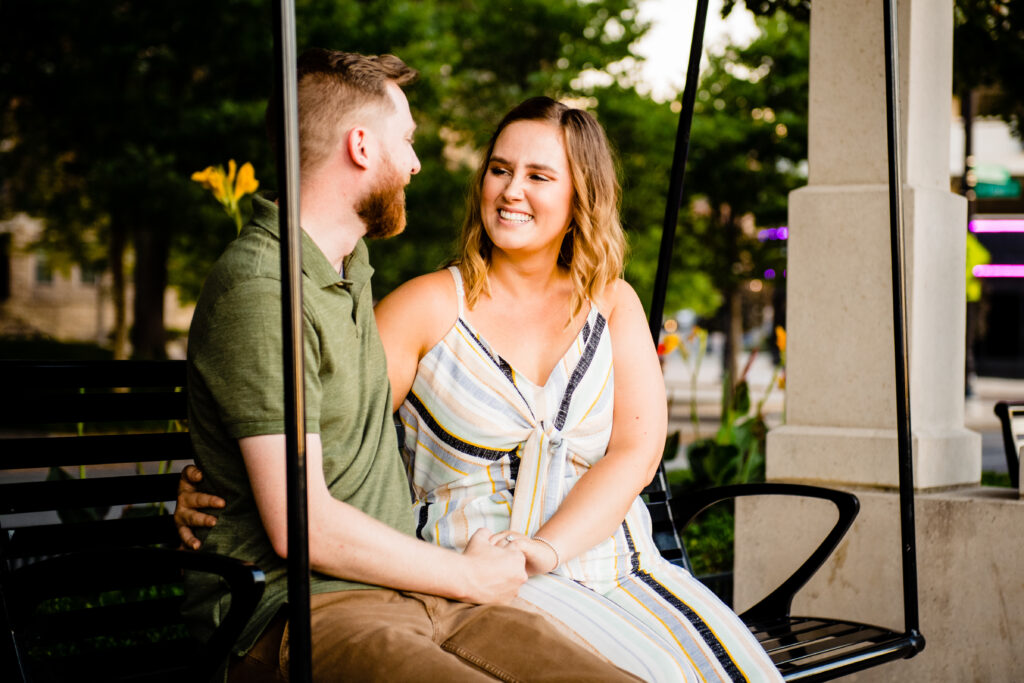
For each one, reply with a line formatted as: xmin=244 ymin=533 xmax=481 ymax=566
xmin=456 ymin=97 xmax=626 ymax=322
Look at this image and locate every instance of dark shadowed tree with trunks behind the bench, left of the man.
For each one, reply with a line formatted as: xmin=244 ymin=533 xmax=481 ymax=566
xmin=0 ymin=0 xmax=269 ymax=357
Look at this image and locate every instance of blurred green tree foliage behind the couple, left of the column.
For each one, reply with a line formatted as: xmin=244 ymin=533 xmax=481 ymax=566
xmin=0 ymin=0 xmax=807 ymax=342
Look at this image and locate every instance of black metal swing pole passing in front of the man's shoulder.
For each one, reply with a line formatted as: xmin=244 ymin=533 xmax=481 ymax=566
xmin=271 ymin=0 xmax=312 ymax=683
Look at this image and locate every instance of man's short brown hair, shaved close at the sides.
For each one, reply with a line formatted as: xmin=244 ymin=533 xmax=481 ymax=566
xmin=266 ymin=47 xmax=419 ymax=172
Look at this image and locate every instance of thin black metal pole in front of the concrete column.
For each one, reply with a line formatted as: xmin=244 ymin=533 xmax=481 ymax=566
xmin=884 ymin=0 xmax=924 ymax=649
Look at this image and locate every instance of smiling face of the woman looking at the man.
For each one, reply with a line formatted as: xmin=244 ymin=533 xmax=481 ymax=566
xmin=480 ymin=121 xmax=573 ymax=260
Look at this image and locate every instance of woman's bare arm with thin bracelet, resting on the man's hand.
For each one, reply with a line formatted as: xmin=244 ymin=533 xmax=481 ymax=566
xmin=509 ymin=281 xmax=668 ymax=574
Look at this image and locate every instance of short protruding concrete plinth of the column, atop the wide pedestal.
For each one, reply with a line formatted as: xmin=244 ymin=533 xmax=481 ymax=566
xmin=767 ymin=425 xmax=981 ymax=488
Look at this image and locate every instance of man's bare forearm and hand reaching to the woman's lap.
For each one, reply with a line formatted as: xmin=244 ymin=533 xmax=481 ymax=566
xmin=239 ymin=434 xmax=526 ymax=603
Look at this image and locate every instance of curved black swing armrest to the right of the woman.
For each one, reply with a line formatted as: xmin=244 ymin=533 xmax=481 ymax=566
xmin=672 ymin=482 xmax=860 ymax=624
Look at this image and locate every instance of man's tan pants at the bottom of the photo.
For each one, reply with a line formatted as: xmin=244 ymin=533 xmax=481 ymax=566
xmin=228 ymin=589 xmax=639 ymax=683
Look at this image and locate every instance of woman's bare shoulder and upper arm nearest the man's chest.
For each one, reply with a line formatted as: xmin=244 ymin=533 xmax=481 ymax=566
xmin=374 ymin=270 xmax=459 ymax=411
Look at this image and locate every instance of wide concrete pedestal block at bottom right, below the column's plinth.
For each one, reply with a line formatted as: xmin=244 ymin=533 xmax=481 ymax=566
xmin=735 ymin=486 xmax=1024 ymax=683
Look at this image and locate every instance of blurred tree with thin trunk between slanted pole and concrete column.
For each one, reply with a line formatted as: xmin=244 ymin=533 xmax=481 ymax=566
xmin=686 ymin=13 xmax=809 ymax=381
